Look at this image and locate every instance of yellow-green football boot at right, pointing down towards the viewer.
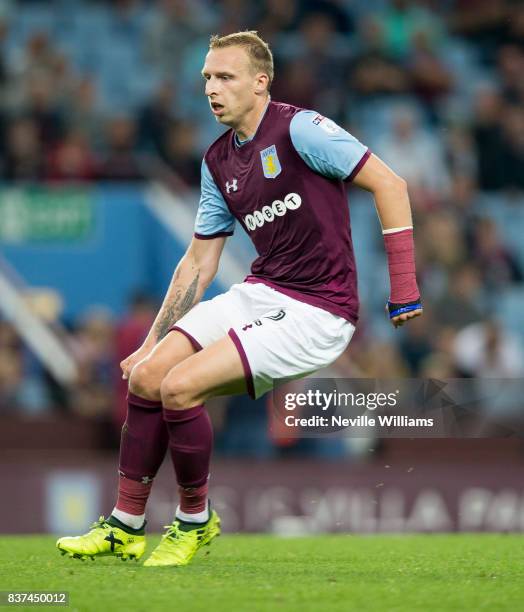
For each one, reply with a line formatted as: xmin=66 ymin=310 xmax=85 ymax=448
xmin=144 ymin=510 xmax=220 ymax=567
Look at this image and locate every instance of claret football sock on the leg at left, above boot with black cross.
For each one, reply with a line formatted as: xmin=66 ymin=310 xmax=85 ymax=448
xmin=115 ymin=393 xmax=169 ymax=527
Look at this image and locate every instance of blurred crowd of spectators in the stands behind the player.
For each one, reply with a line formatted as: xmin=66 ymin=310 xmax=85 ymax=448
xmin=0 ymin=0 xmax=524 ymax=456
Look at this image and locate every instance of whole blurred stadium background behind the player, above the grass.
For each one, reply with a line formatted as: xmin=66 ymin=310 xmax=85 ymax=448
xmin=0 ymin=0 xmax=524 ymax=533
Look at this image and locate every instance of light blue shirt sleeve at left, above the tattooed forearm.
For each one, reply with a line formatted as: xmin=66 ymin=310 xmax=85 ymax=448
xmin=195 ymin=160 xmax=235 ymax=238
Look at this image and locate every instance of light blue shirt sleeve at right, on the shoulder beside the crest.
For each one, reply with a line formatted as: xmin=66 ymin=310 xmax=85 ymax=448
xmin=289 ymin=110 xmax=369 ymax=179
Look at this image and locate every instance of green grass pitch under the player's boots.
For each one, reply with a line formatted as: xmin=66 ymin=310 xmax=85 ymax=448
xmin=0 ymin=535 xmax=524 ymax=612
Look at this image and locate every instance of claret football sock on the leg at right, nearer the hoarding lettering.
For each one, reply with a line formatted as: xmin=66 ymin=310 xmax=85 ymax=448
xmin=164 ymin=406 xmax=213 ymax=506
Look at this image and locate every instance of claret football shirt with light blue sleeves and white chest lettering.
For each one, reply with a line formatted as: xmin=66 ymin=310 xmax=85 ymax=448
xmin=195 ymin=102 xmax=370 ymax=323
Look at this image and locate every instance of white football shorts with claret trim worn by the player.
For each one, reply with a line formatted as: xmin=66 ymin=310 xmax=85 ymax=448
xmin=172 ymin=283 xmax=355 ymax=399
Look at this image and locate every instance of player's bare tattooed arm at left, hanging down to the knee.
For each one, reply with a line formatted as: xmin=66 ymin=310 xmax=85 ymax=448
xmin=120 ymin=237 xmax=226 ymax=379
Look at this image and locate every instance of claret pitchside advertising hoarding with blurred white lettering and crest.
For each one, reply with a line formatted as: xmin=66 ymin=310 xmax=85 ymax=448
xmin=0 ymin=453 xmax=524 ymax=535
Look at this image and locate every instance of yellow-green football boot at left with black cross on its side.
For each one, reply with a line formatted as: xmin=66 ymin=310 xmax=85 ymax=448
xmin=56 ymin=516 xmax=146 ymax=561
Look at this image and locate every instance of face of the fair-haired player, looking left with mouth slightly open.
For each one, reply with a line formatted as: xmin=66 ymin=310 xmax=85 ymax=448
xmin=202 ymin=47 xmax=263 ymax=128
